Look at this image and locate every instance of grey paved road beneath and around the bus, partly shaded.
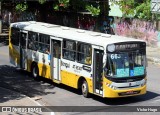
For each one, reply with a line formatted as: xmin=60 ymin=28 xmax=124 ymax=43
xmin=0 ymin=46 xmax=160 ymax=115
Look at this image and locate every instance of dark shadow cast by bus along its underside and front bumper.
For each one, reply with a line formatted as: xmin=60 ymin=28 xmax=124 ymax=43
xmin=49 ymin=79 xmax=160 ymax=105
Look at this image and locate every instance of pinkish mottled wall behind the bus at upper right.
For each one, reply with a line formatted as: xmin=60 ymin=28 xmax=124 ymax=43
xmin=110 ymin=18 xmax=160 ymax=47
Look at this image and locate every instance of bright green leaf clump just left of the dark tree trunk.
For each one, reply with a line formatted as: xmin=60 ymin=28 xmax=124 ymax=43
xmin=86 ymin=5 xmax=100 ymax=16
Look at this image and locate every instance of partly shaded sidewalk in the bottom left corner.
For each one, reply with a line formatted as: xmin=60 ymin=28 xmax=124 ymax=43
xmin=0 ymin=87 xmax=52 ymax=115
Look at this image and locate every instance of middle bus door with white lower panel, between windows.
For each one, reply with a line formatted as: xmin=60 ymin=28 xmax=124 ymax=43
xmin=51 ymin=39 xmax=61 ymax=81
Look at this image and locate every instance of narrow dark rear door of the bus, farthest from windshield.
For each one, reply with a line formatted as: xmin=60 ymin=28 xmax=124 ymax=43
xmin=20 ymin=31 xmax=27 ymax=69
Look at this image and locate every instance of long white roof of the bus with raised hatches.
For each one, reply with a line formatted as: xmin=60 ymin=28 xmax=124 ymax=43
xmin=10 ymin=21 xmax=144 ymax=47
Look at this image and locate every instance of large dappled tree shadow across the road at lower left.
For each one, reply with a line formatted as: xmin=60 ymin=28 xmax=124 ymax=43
xmin=0 ymin=65 xmax=55 ymax=103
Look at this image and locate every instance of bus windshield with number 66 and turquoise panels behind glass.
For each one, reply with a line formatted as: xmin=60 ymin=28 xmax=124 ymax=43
xmin=106 ymin=50 xmax=146 ymax=78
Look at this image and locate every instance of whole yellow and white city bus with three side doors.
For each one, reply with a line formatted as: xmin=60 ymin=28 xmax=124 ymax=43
xmin=9 ymin=21 xmax=147 ymax=98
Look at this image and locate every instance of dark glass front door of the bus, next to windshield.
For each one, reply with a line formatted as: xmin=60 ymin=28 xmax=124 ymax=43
xmin=93 ymin=49 xmax=103 ymax=95
